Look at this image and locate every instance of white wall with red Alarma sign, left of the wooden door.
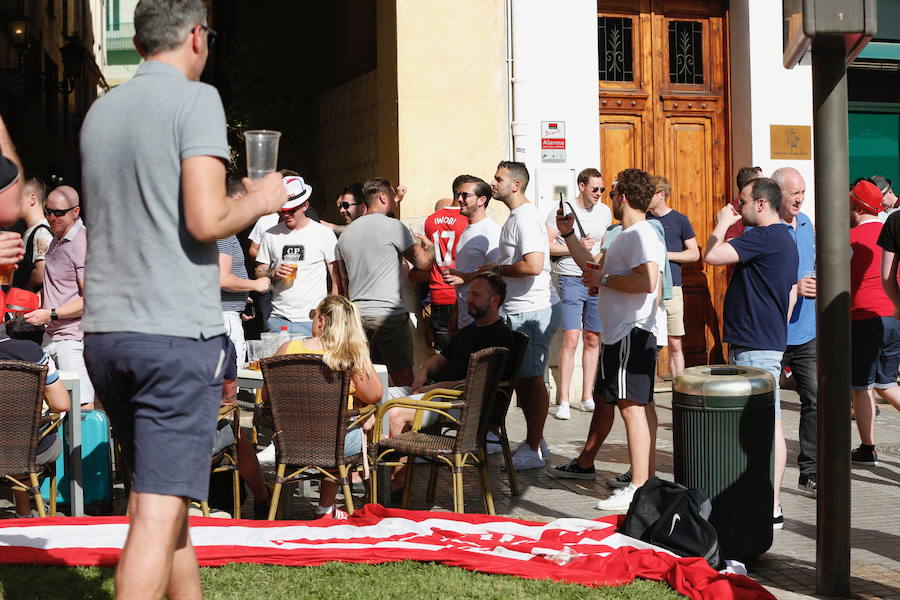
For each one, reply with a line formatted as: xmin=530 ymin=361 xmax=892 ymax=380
xmin=508 ymin=0 xmax=600 ymax=221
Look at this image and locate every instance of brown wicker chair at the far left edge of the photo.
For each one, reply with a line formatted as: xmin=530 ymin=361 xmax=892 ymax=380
xmin=0 ymin=360 xmax=59 ymax=517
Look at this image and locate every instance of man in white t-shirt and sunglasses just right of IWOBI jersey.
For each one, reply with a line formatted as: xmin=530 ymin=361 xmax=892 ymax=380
xmin=444 ymin=175 xmax=500 ymax=331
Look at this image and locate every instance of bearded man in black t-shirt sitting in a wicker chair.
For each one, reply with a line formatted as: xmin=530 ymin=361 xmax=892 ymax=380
xmin=387 ymin=272 xmax=513 ymax=435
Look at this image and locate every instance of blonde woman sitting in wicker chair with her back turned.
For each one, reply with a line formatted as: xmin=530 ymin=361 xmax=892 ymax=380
xmin=275 ymin=296 xmax=382 ymax=519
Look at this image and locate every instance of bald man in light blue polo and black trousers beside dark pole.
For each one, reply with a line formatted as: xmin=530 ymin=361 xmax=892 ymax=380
xmin=772 ymin=167 xmax=819 ymax=495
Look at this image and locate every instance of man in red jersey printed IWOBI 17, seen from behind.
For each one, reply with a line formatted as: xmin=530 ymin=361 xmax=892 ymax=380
xmin=425 ymin=197 xmax=469 ymax=352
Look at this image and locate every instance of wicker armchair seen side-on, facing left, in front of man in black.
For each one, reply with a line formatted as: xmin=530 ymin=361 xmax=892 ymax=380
xmin=371 ymin=348 xmax=509 ymax=514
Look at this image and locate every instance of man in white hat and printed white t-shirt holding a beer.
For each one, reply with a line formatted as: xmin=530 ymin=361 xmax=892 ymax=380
xmin=256 ymin=176 xmax=338 ymax=336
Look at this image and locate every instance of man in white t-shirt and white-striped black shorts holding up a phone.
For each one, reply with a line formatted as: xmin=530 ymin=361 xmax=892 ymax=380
xmin=555 ymin=169 xmax=666 ymax=511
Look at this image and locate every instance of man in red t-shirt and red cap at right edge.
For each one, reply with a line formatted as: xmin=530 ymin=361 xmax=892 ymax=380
xmin=850 ymin=181 xmax=900 ymax=467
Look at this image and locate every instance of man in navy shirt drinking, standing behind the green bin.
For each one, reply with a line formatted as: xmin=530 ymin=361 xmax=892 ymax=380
xmin=703 ymin=177 xmax=799 ymax=529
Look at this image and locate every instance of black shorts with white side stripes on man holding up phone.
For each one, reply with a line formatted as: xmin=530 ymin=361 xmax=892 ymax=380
xmin=594 ymin=327 xmax=656 ymax=404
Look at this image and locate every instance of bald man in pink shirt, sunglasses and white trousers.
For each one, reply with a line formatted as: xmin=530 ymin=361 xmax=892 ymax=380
xmin=25 ymin=185 xmax=94 ymax=408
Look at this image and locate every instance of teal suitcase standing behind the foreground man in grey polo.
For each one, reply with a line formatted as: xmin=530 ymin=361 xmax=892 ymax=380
xmin=41 ymin=410 xmax=112 ymax=511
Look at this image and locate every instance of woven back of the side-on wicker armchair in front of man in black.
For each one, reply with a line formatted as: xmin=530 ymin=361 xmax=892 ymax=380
xmin=454 ymin=348 xmax=509 ymax=453
